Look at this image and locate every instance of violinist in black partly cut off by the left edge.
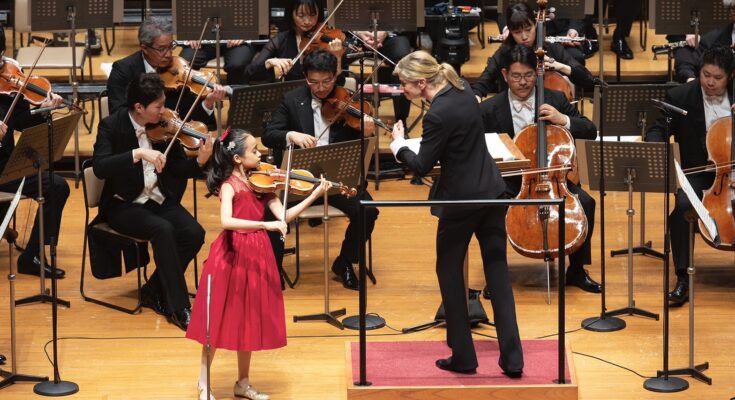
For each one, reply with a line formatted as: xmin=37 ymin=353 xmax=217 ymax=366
xmin=0 ymin=29 xmax=69 ymax=278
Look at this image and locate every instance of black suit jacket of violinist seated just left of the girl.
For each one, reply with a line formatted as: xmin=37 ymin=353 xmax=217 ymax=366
xmin=93 ymin=109 xmax=207 ymax=215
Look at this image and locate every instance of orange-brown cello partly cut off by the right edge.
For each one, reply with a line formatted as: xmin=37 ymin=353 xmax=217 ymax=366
xmin=699 ymin=116 xmax=735 ymax=251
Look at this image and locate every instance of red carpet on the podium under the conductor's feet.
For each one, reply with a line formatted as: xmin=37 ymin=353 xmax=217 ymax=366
xmin=351 ymin=340 xmax=569 ymax=387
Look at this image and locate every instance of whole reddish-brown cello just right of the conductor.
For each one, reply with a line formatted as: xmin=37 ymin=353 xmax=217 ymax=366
xmin=505 ymin=0 xmax=587 ymax=260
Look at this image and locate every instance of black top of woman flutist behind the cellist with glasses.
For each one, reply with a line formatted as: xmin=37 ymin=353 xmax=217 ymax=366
xmin=472 ymin=43 xmax=595 ymax=97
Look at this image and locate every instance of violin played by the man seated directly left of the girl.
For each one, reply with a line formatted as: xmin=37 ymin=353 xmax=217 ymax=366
xmin=145 ymin=108 xmax=209 ymax=157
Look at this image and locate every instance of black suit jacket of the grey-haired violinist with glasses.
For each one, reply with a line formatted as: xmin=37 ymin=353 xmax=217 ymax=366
xmin=107 ymin=51 xmax=217 ymax=131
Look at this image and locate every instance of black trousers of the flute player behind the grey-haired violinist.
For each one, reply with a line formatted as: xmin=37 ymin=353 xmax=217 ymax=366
xmin=180 ymin=44 xmax=255 ymax=85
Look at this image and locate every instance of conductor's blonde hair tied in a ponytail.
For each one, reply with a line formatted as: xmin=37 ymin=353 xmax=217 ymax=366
xmin=393 ymin=50 xmax=464 ymax=90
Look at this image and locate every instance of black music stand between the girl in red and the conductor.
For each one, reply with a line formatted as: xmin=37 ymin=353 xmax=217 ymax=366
xmin=290 ymin=137 xmax=376 ymax=329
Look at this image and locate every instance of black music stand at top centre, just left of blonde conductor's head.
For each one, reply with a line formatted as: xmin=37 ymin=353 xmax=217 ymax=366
xmin=329 ymin=0 xmax=424 ymax=190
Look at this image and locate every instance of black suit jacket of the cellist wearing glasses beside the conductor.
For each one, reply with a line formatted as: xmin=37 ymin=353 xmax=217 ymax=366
xmin=480 ymin=89 xmax=597 ymax=139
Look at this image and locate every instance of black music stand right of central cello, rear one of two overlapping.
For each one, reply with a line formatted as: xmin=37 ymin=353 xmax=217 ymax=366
xmin=593 ymin=83 xmax=678 ymax=258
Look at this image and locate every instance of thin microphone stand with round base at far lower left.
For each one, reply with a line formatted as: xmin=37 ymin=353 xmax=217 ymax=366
xmin=33 ymin=110 xmax=79 ymax=397
